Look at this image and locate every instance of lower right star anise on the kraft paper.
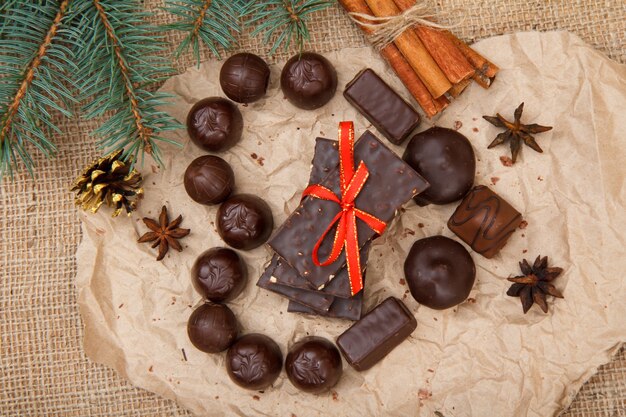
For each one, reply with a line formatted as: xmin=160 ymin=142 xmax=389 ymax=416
xmin=506 ymin=255 xmax=563 ymax=314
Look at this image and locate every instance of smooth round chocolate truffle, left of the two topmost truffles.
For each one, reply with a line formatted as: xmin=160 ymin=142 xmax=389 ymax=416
xmin=220 ymin=53 xmax=270 ymax=103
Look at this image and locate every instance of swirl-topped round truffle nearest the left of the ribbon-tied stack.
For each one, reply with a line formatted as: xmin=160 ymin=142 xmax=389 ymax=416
xmin=216 ymin=194 xmax=274 ymax=250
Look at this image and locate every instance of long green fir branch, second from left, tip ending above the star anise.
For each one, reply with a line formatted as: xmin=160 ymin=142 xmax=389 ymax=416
xmin=73 ymin=0 xmax=182 ymax=164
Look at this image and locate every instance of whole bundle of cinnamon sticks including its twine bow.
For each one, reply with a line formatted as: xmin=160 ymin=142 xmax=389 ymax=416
xmin=339 ymin=0 xmax=499 ymax=117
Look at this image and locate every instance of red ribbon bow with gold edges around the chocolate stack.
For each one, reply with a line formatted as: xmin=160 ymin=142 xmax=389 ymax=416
xmin=302 ymin=122 xmax=387 ymax=295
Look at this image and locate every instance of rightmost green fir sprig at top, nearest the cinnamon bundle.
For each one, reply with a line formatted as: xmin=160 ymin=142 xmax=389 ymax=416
xmin=242 ymin=0 xmax=334 ymax=55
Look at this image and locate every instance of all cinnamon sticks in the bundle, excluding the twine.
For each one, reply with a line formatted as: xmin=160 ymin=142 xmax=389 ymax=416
xmin=339 ymin=0 xmax=499 ymax=117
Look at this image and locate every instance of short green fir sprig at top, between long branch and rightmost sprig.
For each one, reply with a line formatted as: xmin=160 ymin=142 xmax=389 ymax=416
xmin=162 ymin=0 xmax=241 ymax=66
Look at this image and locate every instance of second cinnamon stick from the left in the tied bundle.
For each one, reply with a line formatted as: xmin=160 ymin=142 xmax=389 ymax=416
xmin=365 ymin=0 xmax=452 ymax=98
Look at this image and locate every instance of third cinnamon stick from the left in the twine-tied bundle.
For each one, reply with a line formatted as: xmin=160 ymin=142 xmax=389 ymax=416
xmin=393 ymin=0 xmax=476 ymax=84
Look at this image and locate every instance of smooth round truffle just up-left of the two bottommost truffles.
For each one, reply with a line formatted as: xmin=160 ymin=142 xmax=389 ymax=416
xmin=187 ymin=303 xmax=238 ymax=353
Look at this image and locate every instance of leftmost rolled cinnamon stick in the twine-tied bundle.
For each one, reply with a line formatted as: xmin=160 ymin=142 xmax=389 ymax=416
xmin=339 ymin=0 xmax=449 ymax=117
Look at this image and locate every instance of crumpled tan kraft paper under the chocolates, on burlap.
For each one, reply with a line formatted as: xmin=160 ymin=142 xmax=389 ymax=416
xmin=77 ymin=32 xmax=626 ymax=417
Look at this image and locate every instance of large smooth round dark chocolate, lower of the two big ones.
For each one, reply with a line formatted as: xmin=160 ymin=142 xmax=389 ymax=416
xmin=404 ymin=236 xmax=476 ymax=310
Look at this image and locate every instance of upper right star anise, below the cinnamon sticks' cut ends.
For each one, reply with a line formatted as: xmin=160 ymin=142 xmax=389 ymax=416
xmin=483 ymin=103 xmax=552 ymax=163
